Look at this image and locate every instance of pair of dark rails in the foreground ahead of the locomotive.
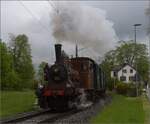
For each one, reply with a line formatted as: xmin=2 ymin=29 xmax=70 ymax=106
xmin=0 ymin=110 xmax=81 ymax=124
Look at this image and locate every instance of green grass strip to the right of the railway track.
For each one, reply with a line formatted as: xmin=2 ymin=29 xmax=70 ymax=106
xmin=91 ymin=95 xmax=145 ymax=124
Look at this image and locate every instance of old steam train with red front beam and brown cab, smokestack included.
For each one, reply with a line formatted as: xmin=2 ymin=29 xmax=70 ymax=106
xmin=37 ymin=44 xmax=106 ymax=109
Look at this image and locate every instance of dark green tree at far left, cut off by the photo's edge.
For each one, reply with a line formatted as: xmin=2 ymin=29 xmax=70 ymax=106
xmin=0 ymin=41 xmax=20 ymax=89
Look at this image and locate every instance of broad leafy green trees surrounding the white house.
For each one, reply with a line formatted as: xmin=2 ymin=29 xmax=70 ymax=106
xmin=102 ymin=41 xmax=149 ymax=85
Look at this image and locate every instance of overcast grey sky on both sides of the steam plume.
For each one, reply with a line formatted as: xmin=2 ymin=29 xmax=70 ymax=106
xmin=0 ymin=1 xmax=148 ymax=64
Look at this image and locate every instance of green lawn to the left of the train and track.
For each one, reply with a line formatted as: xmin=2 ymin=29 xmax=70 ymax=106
xmin=0 ymin=91 xmax=36 ymax=118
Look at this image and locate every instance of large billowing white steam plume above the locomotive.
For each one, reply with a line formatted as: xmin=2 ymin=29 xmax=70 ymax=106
xmin=51 ymin=2 xmax=117 ymax=55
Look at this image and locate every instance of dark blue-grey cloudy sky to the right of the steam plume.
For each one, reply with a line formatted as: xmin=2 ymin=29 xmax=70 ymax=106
xmin=90 ymin=1 xmax=148 ymax=40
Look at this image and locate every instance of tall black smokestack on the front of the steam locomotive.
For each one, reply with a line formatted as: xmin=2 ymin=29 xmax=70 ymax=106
xmin=55 ymin=44 xmax=62 ymax=63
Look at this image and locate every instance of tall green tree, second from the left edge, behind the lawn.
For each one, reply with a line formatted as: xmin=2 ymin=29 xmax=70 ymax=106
xmin=10 ymin=34 xmax=34 ymax=88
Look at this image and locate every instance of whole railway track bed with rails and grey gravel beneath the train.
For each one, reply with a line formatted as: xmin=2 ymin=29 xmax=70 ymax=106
xmin=0 ymin=97 xmax=110 ymax=124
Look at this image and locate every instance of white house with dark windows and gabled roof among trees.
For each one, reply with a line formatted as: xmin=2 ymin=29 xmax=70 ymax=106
xmin=111 ymin=63 xmax=139 ymax=83
